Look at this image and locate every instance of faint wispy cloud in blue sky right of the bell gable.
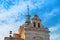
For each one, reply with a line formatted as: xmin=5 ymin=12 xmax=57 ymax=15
xmin=43 ymin=8 xmax=60 ymax=23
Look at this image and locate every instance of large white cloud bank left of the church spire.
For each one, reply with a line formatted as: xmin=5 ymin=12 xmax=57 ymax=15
xmin=0 ymin=3 xmax=26 ymax=40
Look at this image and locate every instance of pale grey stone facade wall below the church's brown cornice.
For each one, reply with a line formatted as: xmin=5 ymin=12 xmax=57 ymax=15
xmin=25 ymin=31 xmax=49 ymax=40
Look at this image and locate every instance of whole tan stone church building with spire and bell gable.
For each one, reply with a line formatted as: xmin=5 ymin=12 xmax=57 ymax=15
xmin=4 ymin=5 xmax=50 ymax=40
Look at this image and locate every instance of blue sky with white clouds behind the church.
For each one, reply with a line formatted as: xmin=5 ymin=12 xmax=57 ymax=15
xmin=0 ymin=0 xmax=60 ymax=40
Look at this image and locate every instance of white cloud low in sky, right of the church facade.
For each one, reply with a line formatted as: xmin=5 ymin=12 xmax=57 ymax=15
xmin=49 ymin=24 xmax=60 ymax=40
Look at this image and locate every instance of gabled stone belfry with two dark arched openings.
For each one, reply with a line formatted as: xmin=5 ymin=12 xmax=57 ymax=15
xmin=31 ymin=14 xmax=42 ymax=28
